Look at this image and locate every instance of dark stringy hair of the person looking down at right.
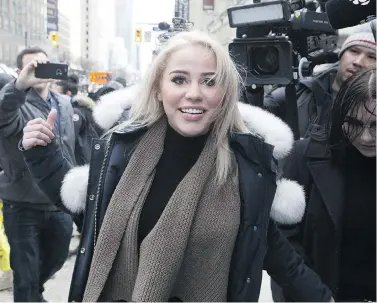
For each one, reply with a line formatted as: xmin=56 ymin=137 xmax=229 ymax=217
xmin=311 ymin=68 xmax=376 ymax=158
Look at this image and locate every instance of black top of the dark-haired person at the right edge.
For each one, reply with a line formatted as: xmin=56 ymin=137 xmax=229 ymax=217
xmin=337 ymin=146 xmax=376 ymax=301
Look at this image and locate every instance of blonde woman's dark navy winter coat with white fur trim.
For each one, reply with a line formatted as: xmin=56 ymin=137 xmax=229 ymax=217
xmin=24 ymin=91 xmax=331 ymax=301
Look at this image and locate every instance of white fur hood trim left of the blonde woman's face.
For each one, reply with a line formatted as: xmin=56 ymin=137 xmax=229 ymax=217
xmin=93 ymin=85 xmax=137 ymax=131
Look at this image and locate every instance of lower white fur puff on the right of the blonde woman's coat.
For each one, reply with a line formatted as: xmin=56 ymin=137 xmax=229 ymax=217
xmin=271 ymin=179 xmax=306 ymax=224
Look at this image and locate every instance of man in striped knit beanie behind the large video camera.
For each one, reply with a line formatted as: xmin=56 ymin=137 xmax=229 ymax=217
xmin=264 ymin=32 xmax=376 ymax=138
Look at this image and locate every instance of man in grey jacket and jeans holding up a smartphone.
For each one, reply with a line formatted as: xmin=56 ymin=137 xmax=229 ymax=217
xmin=0 ymin=48 xmax=75 ymax=302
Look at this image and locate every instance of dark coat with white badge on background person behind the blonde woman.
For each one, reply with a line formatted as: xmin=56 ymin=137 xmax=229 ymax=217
xmin=71 ymin=95 xmax=102 ymax=165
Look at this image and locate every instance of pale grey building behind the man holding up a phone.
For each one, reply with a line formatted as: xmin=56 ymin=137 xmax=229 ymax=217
xmin=0 ymin=0 xmax=49 ymax=67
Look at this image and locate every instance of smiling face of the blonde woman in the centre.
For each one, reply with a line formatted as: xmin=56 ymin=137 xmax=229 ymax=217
xmin=159 ymin=45 xmax=223 ymax=137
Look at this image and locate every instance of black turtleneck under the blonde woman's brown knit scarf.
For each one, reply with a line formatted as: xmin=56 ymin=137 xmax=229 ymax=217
xmin=138 ymin=126 xmax=208 ymax=247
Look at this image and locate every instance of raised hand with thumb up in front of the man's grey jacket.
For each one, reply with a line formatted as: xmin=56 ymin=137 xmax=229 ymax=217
xmin=22 ymin=109 xmax=56 ymax=150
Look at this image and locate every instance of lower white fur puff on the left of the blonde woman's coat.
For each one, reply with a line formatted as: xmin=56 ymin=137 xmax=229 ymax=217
xmin=60 ymin=165 xmax=89 ymax=213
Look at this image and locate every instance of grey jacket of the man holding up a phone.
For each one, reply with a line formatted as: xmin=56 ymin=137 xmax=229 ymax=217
xmin=0 ymin=81 xmax=75 ymax=207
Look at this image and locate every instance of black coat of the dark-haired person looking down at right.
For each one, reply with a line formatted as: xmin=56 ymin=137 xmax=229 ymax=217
xmin=273 ymin=139 xmax=352 ymax=301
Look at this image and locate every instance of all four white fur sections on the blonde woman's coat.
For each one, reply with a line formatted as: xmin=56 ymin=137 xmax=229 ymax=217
xmin=61 ymin=86 xmax=305 ymax=224
